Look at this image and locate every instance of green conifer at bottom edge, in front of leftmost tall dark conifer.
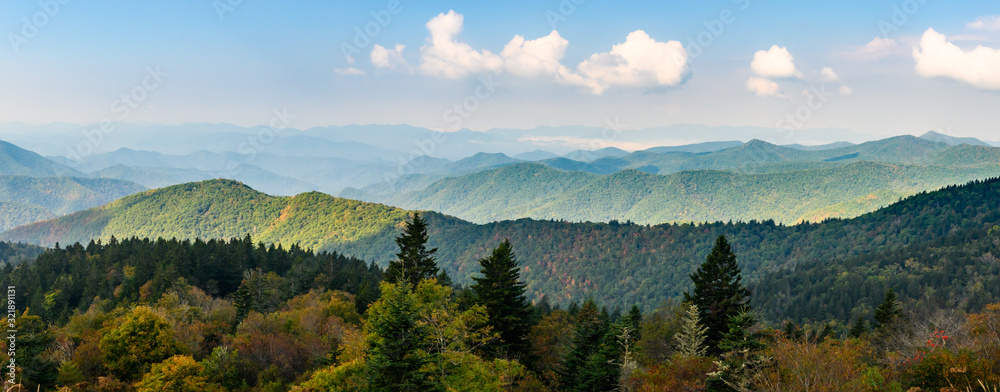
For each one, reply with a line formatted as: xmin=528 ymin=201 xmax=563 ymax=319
xmin=365 ymin=281 xmax=436 ymax=392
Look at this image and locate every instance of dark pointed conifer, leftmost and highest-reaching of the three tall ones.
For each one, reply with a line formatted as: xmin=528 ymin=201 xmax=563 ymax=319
xmin=385 ymin=212 xmax=438 ymax=288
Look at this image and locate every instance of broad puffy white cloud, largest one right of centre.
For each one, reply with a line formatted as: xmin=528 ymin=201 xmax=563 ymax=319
xmin=577 ymin=30 xmax=688 ymax=94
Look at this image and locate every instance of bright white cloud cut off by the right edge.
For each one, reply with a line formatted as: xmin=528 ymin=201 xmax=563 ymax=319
xmin=913 ymin=29 xmax=1000 ymax=90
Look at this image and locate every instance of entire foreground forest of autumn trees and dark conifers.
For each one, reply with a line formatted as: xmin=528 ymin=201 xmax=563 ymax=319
xmin=0 ymin=215 xmax=1000 ymax=392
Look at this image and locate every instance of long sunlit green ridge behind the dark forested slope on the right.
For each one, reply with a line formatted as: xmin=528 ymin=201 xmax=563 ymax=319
xmin=371 ymin=161 xmax=1000 ymax=224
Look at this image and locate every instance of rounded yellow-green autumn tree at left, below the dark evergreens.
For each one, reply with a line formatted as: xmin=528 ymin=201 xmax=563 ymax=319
xmin=100 ymin=306 xmax=178 ymax=380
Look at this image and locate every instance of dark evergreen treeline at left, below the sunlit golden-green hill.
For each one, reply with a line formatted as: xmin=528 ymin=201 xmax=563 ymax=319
xmin=0 ymin=235 xmax=382 ymax=323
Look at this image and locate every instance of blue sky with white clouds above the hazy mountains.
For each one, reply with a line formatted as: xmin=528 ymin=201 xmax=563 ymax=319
xmin=0 ymin=0 xmax=1000 ymax=140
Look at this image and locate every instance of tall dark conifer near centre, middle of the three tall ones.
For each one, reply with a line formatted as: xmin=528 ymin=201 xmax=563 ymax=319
xmin=472 ymin=240 xmax=531 ymax=361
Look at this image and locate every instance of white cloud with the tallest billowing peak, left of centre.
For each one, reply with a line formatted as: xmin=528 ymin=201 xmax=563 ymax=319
xmin=420 ymin=10 xmax=503 ymax=79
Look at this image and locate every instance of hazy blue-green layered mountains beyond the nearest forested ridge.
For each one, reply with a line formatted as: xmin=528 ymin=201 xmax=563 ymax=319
xmin=0 ymin=123 xmax=1000 ymax=233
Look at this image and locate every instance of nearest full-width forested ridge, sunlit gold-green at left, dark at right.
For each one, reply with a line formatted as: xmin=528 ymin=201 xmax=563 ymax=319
xmin=0 ymin=176 xmax=1000 ymax=320
